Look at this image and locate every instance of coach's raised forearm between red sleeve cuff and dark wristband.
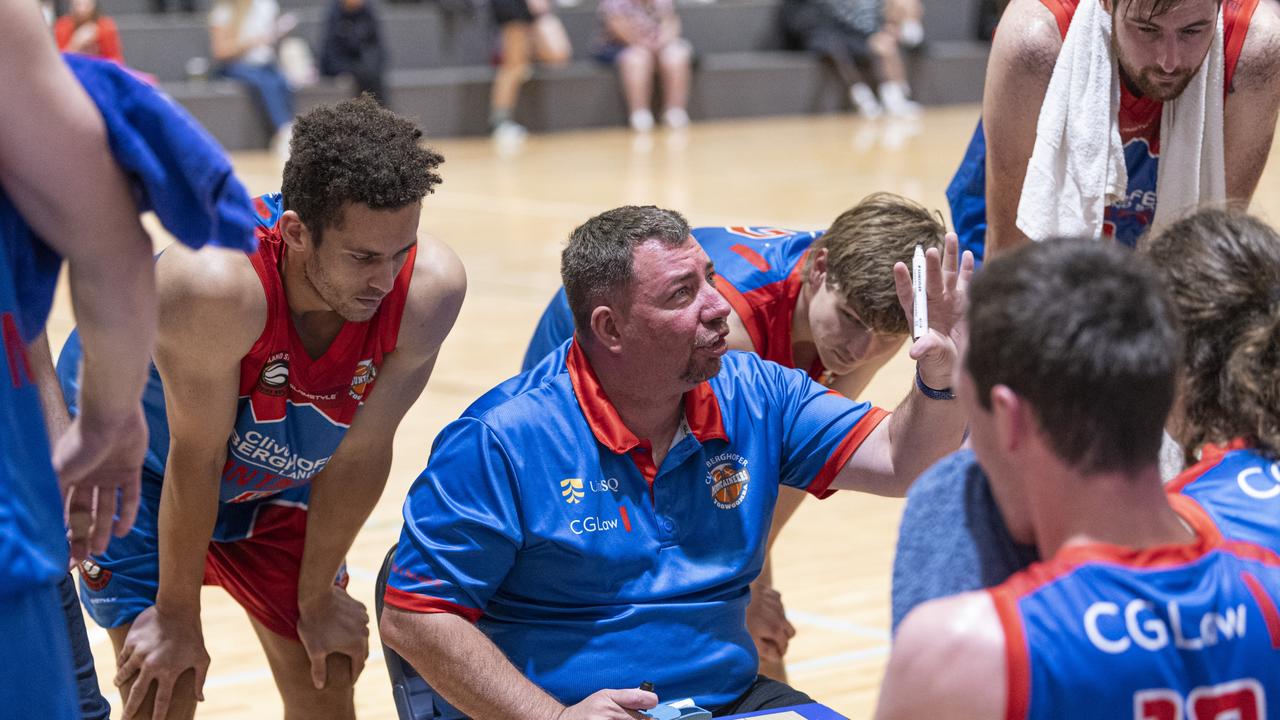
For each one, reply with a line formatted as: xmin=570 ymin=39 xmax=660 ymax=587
xmin=888 ymin=386 xmax=965 ymax=497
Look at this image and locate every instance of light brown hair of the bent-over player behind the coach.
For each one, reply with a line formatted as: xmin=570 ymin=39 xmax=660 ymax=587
xmin=805 ymin=192 xmax=947 ymax=334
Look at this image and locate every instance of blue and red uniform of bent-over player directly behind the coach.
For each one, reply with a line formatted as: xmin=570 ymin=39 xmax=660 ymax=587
xmin=521 ymin=225 xmax=824 ymax=368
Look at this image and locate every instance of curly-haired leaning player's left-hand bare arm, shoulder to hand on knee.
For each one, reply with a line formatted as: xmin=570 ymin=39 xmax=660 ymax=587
xmin=113 ymin=246 xmax=266 ymax=717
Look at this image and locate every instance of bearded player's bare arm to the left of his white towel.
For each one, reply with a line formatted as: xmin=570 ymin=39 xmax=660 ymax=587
xmin=982 ymin=0 xmax=1062 ymax=258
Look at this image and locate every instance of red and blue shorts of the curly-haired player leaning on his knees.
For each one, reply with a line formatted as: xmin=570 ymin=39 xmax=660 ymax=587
xmin=81 ymin=473 xmax=347 ymax=639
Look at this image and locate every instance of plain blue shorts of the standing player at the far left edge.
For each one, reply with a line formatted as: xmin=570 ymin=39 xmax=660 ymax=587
xmin=0 ymin=578 xmax=79 ymax=720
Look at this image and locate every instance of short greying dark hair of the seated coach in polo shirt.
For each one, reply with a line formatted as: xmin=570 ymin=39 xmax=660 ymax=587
xmin=561 ymin=205 xmax=689 ymax=333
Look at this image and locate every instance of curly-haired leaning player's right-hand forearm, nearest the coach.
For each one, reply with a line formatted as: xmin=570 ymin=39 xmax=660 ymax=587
xmin=298 ymin=443 xmax=392 ymax=604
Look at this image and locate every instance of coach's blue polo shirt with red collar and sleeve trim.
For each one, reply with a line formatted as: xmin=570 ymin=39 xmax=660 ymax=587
xmin=385 ymin=341 xmax=887 ymax=706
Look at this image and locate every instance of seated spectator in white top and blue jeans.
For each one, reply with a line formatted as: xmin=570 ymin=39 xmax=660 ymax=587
xmin=209 ymin=0 xmax=297 ymax=156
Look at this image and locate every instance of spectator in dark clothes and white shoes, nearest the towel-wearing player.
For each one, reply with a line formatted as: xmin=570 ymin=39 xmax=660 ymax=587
xmin=780 ymin=0 xmax=920 ymax=118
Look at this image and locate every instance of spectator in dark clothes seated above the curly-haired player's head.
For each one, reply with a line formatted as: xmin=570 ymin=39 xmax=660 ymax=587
xmin=320 ymin=0 xmax=387 ymax=105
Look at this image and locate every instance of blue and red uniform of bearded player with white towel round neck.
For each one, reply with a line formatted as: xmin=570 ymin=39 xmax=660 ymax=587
xmin=947 ymin=0 xmax=1258 ymax=260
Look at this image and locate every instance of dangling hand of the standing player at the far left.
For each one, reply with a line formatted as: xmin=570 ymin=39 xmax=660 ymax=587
xmin=54 ymin=405 xmax=147 ymax=561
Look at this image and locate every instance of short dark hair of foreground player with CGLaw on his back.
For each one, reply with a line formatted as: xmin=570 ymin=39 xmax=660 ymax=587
xmin=965 ymin=240 xmax=1180 ymax=473
